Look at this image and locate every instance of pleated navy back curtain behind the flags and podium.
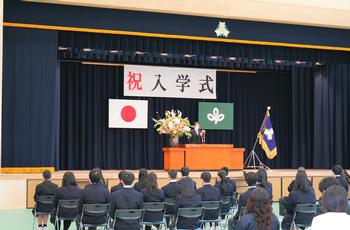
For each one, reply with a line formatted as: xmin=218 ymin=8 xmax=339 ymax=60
xmin=60 ymin=62 xmax=292 ymax=169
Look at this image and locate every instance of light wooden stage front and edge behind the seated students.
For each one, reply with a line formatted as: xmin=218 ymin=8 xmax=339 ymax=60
xmin=0 ymin=169 xmax=344 ymax=209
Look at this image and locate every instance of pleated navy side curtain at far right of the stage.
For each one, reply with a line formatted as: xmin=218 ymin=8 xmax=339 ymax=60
xmin=313 ymin=64 xmax=350 ymax=168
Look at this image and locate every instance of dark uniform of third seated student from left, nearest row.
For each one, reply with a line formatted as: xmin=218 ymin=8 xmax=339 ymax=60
xmin=79 ymin=183 xmax=110 ymax=224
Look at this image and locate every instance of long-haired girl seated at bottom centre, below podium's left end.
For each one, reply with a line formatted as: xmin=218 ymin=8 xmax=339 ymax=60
xmin=175 ymin=177 xmax=202 ymax=229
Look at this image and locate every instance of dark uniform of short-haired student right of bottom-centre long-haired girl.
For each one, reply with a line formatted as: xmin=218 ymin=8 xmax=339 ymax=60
xmin=197 ymin=183 xmax=221 ymax=220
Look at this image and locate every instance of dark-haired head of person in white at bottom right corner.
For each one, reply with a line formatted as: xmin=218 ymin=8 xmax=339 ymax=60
xmin=321 ymin=185 xmax=348 ymax=213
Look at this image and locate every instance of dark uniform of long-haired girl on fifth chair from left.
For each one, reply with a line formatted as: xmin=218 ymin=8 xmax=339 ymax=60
xmin=141 ymin=188 xmax=165 ymax=222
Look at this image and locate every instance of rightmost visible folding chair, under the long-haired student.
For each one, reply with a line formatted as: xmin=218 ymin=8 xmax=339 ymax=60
xmin=290 ymin=203 xmax=317 ymax=230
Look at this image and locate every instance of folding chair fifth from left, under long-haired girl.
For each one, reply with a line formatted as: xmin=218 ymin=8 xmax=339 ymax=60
xmin=141 ymin=202 xmax=166 ymax=227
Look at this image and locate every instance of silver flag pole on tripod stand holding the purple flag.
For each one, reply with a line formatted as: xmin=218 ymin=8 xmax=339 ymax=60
xmin=244 ymin=106 xmax=271 ymax=170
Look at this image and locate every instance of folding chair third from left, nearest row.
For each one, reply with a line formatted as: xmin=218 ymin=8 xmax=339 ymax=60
xmin=79 ymin=204 xmax=109 ymax=230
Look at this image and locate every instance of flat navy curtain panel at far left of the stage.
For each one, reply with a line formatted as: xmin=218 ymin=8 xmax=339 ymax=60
xmin=2 ymin=27 xmax=59 ymax=167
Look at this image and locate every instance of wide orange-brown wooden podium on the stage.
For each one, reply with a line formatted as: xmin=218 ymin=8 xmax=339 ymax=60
xmin=163 ymin=144 xmax=245 ymax=170
